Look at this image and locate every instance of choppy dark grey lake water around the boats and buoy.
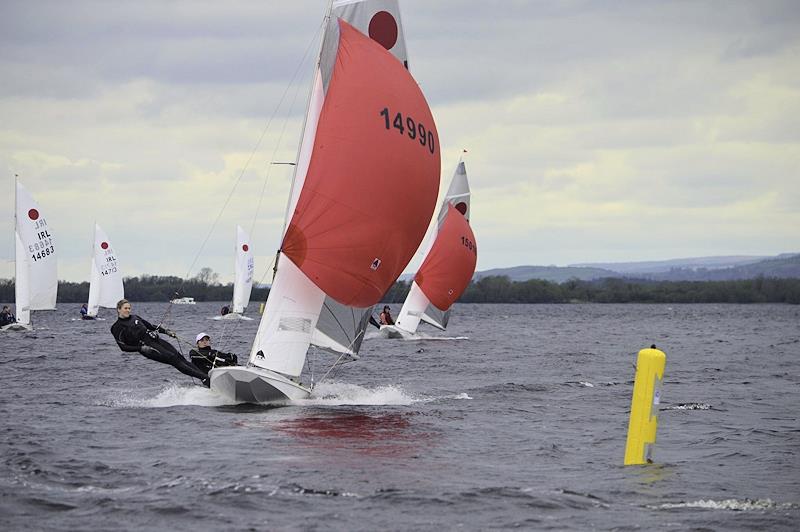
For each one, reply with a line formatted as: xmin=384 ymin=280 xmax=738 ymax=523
xmin=0 ymin=304 xmax=800 ymax=531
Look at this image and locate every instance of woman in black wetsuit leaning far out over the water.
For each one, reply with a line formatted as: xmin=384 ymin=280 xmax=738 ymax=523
xmin=111 ymin=299 xmax=208 ymax=386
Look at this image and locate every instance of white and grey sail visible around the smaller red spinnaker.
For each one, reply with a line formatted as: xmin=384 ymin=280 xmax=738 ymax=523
xmin=395 ymin=161 xmax=470 ymax=333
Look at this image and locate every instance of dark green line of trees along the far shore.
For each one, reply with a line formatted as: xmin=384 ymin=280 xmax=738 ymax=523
xmin=0 ymin=272 xmax=800 ymax=305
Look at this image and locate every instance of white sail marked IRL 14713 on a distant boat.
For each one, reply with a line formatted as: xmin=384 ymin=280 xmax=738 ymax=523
xmin=86 ymin=224 xmax=125 ymax=317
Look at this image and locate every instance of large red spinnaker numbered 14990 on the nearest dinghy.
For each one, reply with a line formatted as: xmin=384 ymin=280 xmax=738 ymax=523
xmin=282 ymin=20 xmax=440 ymax=307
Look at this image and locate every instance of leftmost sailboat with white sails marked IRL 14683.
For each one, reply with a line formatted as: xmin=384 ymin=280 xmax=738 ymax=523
xmin=3 ymin=181 xmax=58 ymax=330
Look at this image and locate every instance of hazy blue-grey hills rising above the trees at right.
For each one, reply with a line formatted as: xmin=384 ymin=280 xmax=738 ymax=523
xmin=468 ymin=253 xmax=800 ymax=283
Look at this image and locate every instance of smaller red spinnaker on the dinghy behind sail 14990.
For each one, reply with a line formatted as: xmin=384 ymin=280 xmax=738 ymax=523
xmin=414 ymin=205 xmax=478 ymax=311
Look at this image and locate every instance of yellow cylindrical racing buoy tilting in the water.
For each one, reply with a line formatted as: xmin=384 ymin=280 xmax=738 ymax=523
xmin=625 ymin=345 xmax=667 ymax=465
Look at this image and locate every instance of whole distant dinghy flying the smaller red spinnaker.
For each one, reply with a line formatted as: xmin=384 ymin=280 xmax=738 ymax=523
xmin=381 ymin=161 xmax=478 ymax=338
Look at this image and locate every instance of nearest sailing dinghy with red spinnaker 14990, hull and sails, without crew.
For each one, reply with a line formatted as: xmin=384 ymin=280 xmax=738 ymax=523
xmin=209 ymin=0 xmax=441 ymax=403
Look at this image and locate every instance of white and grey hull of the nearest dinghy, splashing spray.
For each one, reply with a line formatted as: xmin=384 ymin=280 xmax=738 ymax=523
xmin=208 ymin=366 xmax=311 ymax=405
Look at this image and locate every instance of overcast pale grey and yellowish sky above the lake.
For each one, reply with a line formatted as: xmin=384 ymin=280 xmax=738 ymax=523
xmin=0 ymin=0 xmax=800 ymax=281
